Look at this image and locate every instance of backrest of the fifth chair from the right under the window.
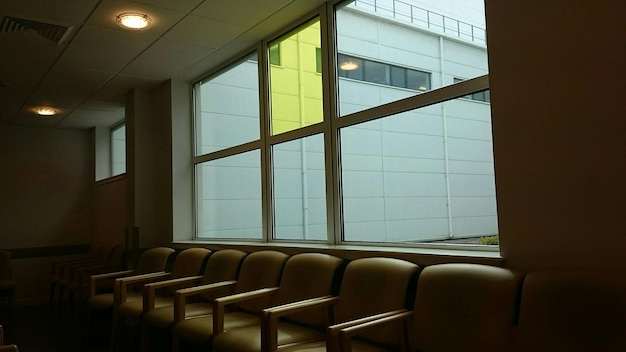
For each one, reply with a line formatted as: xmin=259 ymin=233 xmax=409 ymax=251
xmin=230 ymin=250 xmax=289 ymax=313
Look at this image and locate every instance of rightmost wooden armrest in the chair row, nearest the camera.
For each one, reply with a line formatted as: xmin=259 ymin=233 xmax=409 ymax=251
xmin=334 ymin=309 xmax=413 ymax=352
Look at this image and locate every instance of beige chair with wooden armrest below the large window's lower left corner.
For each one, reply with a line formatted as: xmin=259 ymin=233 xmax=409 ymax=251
xmin=111 ymin=248 xmax=211 ymax=350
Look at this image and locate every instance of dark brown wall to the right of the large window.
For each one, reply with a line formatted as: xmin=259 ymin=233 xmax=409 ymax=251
xmin=486 ymin=0 xmax=626 ymax=269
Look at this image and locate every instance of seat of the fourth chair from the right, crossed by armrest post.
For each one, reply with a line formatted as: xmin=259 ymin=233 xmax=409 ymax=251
xmin=213 ymin=322 xmax=326 ymax=352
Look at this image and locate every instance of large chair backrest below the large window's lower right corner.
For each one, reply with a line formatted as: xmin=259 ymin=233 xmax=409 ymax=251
xmin=411 ymin=263 xmax=523 ymax=352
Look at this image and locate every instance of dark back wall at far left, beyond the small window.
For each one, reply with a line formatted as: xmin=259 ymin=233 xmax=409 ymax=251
xmin=0 ymin=124 xmax=94 ymax=303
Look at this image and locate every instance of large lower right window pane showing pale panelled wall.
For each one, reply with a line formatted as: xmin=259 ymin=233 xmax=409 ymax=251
xmin=340 ymin=99 xmax=498 ymax=243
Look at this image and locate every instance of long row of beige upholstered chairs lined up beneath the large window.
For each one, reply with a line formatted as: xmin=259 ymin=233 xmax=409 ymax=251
xmin=68 ymin=248 xmax=626 ymax=352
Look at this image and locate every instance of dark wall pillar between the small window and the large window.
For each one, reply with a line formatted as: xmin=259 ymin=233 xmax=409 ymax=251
xmin=126 ymin=83 xmax=172 ymax=248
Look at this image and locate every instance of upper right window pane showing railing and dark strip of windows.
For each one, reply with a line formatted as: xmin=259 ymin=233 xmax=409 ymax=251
xmin=336 ymin=0 xmax=488 ymax=116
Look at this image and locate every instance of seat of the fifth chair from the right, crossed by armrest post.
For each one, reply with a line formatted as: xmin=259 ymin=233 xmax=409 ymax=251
xmin=174 ymin=312 xmax=260 ymax=351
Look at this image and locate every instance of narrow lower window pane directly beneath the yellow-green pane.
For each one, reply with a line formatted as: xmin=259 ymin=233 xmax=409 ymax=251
xmin=272 ymin=135 xmax=327 ymax=241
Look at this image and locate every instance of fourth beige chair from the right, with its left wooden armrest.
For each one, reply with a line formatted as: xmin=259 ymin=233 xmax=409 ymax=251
xmin=213 ymin=253 xmax=343 ymax=352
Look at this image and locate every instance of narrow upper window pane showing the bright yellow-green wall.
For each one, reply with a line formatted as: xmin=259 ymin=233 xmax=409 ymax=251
xmin=269 ymin=20 xmax=323 ymax=134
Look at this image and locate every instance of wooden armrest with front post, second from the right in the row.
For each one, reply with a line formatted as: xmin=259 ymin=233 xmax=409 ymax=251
xmin=261 ymin=296 xmax=338 ymax=351
